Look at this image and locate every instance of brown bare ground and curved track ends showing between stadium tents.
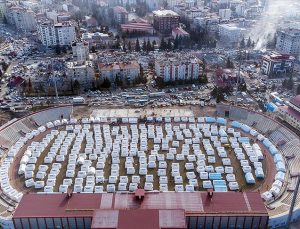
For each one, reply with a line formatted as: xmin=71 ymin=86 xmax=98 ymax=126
xmin=10 ymin=123 xmax=275 ymax=193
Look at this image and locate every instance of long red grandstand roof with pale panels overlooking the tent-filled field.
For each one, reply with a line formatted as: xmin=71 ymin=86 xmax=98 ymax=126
xmin=14 ymin=192 xmax=267 ymax=218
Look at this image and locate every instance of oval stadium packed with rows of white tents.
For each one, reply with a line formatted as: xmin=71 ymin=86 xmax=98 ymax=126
xmin=0 ymin=105 xmax=300 ymax=228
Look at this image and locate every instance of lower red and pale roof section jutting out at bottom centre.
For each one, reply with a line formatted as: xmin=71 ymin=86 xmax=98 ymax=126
xmin=91 ymin=209 xmax=186 ymax=229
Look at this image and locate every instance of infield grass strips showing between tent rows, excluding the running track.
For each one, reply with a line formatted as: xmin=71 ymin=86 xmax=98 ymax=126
xmin=12 ymin=123 xmax=265 ymax=192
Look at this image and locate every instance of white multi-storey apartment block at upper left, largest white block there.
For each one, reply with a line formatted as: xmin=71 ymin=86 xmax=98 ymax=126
xmin=38 ymin=22 xmax=76 ymax=46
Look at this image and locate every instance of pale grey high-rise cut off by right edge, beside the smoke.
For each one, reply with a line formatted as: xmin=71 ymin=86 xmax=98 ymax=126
xmin=276 ymin=29 xmax=300 ymax=56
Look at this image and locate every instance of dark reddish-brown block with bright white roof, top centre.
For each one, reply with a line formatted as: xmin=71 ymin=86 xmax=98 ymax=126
xmin=153 ymin=10 xmax=179 ymax=34
